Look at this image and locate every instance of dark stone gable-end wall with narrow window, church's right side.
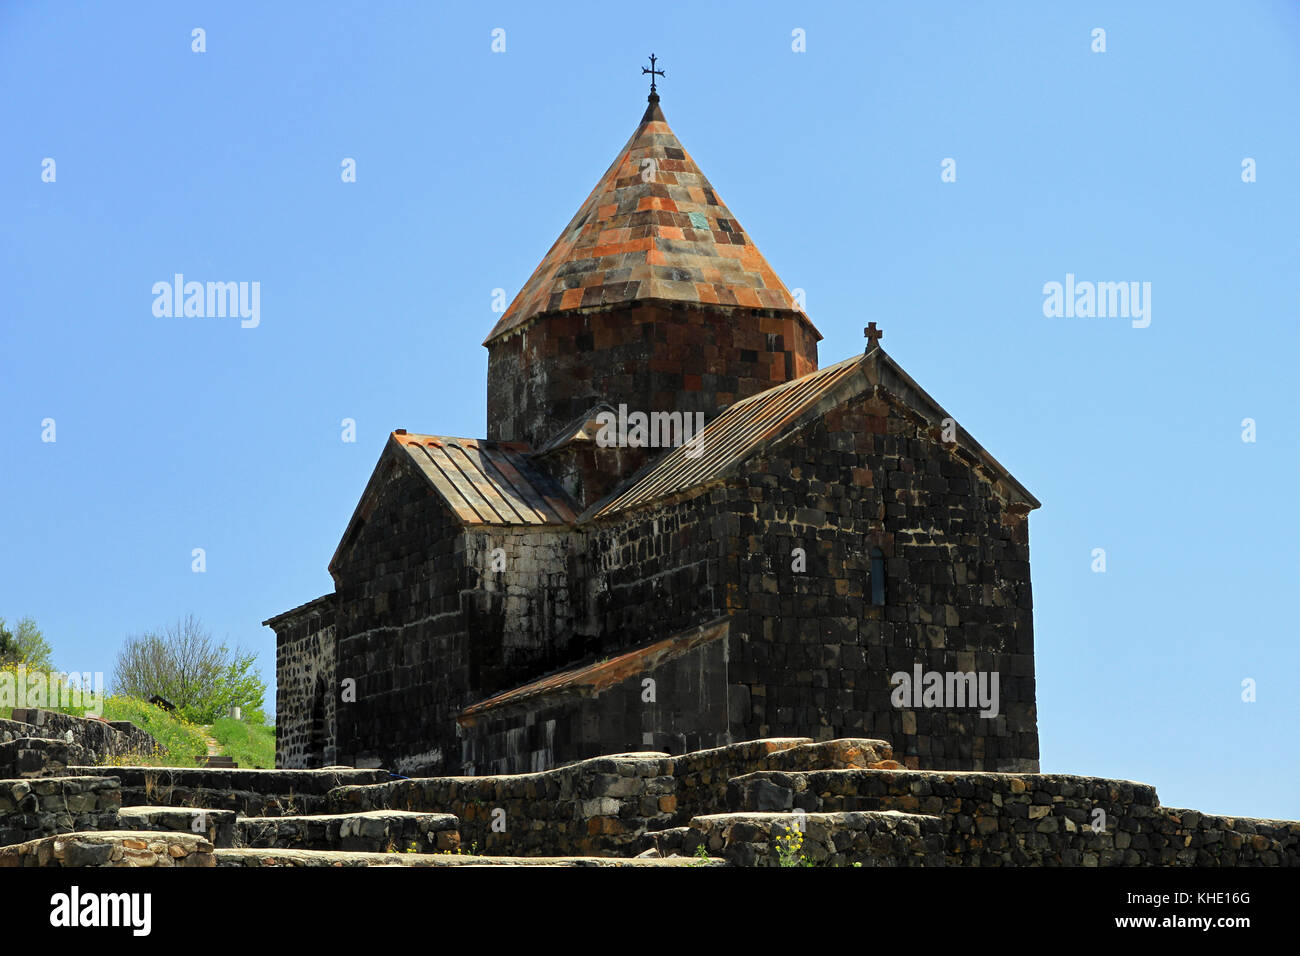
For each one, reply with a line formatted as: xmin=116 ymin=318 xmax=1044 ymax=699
xmin=728 ymin=393 xmax=1039 ymax=770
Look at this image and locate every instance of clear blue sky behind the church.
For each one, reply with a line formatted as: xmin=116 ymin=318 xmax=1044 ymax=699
xmin=0 ymin=1 xmax=1300 ymax=819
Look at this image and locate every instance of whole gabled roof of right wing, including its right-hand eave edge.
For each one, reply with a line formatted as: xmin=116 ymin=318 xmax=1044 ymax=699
xmin=595 ymin=346 xmax=1039 ymax=520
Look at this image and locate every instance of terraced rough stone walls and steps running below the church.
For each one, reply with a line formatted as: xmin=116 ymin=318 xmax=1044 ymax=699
xmin=0 ymin=736 xmax=1300 ymax=868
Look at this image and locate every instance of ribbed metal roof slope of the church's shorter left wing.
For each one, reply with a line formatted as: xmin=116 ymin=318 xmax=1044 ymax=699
xmin=393 ymin=432 xmax=577 ymax=524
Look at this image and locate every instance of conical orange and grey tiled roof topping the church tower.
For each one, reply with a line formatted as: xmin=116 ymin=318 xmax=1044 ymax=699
xmin=484 ymin=96 xmax=820 ymax=345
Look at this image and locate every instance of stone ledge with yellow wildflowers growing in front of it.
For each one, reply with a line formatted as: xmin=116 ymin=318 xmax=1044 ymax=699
xmin=683 ymin=810 xmax=948 ymax=866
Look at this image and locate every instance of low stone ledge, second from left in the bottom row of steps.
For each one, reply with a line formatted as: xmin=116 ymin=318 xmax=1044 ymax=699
xmin=235 ymin=810 xmax=460 ymax=853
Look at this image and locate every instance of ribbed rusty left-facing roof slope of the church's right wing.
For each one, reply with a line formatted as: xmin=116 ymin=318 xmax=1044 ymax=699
xmin=593 ymin=355 xmax=866 ymax=518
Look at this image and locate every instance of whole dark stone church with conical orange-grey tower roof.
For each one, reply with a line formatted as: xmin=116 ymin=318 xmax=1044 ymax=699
xmin=265 ymin=91 xmax=1039 ymax=775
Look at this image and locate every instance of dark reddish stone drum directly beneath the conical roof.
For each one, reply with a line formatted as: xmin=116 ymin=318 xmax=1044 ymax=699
xmin=488 ymin=303 xmax=818 ymax=449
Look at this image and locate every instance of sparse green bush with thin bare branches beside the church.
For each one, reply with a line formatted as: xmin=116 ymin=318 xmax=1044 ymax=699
xmin=113 ymin=614 xmax=267 ymax=723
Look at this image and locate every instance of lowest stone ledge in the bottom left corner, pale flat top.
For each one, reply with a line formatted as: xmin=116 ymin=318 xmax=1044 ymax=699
xmin=0 ymin=830 xmax=216 ymax=868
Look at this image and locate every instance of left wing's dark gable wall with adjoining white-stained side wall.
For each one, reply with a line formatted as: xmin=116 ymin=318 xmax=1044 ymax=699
xmin=325 ymin=455 xmax=592 ymax=774
